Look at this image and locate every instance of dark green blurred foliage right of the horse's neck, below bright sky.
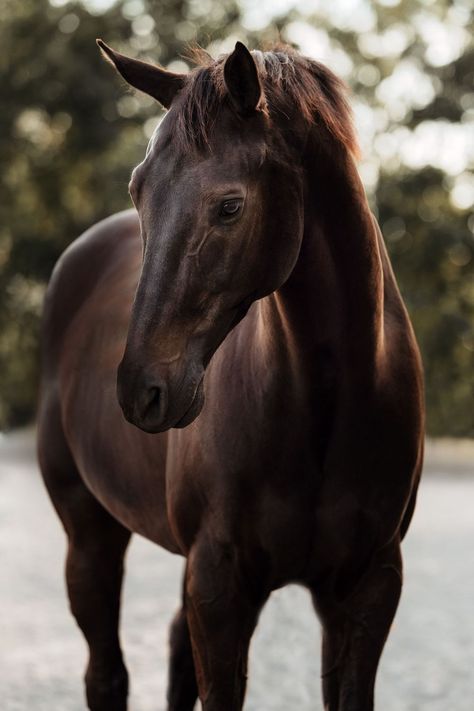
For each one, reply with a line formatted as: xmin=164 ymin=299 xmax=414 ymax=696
xmin=377 ymin=168 xmax=474 ymax=436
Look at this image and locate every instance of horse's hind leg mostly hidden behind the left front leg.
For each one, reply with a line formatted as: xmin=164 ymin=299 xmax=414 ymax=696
xmin=168 ymin=607 xmax=198 ymax=711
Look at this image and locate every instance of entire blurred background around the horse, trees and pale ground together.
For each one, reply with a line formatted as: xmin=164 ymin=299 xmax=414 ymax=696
xmin=0 ymin=0 xmax=474 ymax=711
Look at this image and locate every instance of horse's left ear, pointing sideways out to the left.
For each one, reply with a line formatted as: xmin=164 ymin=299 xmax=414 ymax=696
xmin=96 ymin=39 xmax=186 ymax=109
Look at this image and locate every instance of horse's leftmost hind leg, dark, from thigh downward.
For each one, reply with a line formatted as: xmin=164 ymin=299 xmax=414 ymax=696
xmin=39 ymin=400 xmax=130 ymax=711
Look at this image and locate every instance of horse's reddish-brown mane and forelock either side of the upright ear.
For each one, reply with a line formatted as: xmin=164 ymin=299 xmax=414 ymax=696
xmin=175 ymin=46 xmax=358 ymax=160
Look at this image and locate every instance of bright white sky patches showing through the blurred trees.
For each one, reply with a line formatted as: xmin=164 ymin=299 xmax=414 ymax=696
xmin=50 ymin=0 xmax=474 ymax=209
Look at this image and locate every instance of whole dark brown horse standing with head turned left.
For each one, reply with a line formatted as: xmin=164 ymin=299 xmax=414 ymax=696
xmin=39 ymin=42 xmax=423 ymax=711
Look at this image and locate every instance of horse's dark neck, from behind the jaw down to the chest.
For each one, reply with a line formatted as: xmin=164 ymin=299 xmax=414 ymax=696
xmin=271 ymin=142 xmax=384 ymax=380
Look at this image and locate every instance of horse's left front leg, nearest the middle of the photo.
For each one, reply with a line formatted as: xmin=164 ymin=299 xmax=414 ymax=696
xmin=186 ymin=541 xmax=266 ymax=711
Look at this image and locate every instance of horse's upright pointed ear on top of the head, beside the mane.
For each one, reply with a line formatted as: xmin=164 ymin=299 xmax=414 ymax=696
xmin=224 ymin=42 xmax=262 ymax=116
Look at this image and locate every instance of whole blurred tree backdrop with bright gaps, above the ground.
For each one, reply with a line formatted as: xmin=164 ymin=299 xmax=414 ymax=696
xmin=0 ymin=0 xmax=474 ymax=436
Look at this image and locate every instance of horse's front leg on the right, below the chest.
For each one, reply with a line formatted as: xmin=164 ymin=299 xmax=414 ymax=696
xmin=316 ymin=542 xmax=402 ymax=711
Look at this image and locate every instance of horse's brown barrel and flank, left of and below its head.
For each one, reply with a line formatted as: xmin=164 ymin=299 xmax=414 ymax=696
xmin=40 ymin=211 xmax=180 ymax=550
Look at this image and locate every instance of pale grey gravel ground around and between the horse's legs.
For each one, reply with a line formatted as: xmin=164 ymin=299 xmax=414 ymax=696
xmin=0 ymin=432 xmax=474 ymax=711
